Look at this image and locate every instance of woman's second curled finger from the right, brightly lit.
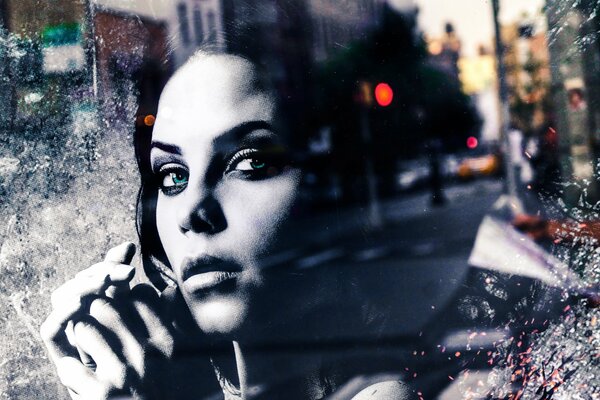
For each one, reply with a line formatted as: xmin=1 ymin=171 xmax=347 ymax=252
xmin=90 ymin=298 xmax=146 ymax=375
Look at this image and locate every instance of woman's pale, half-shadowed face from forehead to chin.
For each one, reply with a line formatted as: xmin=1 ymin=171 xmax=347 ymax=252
xmin=151 ymin=55 xmax=299 ymax=334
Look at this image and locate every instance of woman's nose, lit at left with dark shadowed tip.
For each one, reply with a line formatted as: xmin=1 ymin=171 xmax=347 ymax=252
xmin=177 ymin=186 xmax=227 ymax=234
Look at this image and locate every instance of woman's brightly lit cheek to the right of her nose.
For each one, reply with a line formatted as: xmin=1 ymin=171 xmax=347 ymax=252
xmin=222 ymin=170 xmax=300 ymax=258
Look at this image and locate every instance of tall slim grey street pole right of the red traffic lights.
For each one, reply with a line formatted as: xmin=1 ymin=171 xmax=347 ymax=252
xmin=492 ymin=0 xmax=522 ymax=212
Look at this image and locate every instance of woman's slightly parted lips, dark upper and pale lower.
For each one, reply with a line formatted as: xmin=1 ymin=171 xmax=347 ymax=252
xmin=181 ymin=255 xmax=242 ymax=291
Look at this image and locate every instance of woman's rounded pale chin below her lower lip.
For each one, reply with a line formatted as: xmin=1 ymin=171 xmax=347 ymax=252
xmin=188 ymin=295 xmax=248 ymax=340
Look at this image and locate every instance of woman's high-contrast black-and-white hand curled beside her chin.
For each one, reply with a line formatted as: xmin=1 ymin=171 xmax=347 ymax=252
xmin=40 ymin=243 xmax=174 ymax=399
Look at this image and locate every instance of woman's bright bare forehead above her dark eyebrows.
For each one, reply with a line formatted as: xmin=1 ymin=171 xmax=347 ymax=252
xmin=153 ymin=55 xmax=275 ymax=142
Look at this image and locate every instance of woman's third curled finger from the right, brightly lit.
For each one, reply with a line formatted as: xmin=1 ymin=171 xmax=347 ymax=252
xmin=74 ymin=317 xmax=130 ymax=389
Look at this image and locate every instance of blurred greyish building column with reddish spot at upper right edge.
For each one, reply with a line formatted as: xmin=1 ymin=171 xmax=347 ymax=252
xmin=546 ymin=0 xmax=600 ymax=179
